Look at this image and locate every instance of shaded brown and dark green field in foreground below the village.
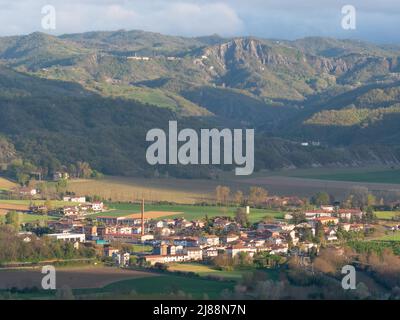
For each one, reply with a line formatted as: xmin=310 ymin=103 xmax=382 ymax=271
xmin=0 ymin=267 xmax=235 ymax=299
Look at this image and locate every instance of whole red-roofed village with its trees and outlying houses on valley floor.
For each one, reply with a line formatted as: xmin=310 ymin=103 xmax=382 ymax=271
xmin=8 ymin=182 xmax=394 ymax=267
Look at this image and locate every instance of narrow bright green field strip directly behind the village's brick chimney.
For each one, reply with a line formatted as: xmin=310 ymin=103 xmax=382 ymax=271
xmin=92 ymin=203 xmax=284 ymax=222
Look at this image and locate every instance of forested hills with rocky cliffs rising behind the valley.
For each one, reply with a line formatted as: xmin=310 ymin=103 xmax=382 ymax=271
xmin=0 ymin=31 xmax=400 ymax=177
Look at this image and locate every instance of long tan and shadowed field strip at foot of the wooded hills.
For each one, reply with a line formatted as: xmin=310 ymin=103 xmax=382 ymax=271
xmin=67 ymin=167 xmax=400 ymax=204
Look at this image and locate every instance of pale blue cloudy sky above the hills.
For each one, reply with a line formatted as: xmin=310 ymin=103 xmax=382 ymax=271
xmin=0 ymin=0 xmax=400 ymax=43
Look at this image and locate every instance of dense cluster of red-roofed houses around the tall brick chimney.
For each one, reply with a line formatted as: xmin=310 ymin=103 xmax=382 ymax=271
xmin=23 ymin=197 xmax=374 ymax=266
